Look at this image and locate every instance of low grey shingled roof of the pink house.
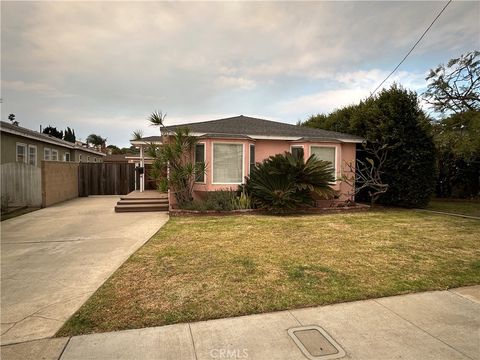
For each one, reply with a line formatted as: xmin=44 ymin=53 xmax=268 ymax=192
xmin=163 ymin=115 xmax=363 ymax=143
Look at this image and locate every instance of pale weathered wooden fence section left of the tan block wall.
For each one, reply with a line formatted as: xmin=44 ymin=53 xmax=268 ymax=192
xmin=0 ymin=163 xmax=42 ymax=207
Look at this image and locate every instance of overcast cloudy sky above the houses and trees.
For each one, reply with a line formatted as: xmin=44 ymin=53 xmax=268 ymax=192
xmin=1 ymin=1 xmax=480 ymax=146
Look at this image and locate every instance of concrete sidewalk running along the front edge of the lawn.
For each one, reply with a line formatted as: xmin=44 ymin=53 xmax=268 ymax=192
xmin=1 ymin=285 xmax=480 ymax=360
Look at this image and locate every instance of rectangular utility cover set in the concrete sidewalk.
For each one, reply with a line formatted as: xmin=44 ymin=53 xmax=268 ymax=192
xmin=288 ymin=326 xmax=345 ymax=360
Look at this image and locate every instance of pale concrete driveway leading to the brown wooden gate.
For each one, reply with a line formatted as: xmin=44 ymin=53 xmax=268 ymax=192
xmin=1 ymin=196 xmax=168 ymax=345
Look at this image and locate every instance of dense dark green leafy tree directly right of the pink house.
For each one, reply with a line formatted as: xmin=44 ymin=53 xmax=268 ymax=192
xmin=304 ymin=84 xmax=435 ymax=207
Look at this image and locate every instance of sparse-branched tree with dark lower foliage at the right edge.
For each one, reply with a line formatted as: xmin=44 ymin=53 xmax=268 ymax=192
xmin=423 ymin=51 xmax=480 ymax=198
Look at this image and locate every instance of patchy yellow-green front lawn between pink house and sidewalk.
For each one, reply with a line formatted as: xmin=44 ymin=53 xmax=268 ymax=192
xmin=57 ymin=210 xmax=480 ymax=336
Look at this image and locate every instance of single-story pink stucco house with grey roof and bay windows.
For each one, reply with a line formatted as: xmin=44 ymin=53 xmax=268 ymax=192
xmin=132 ymin=115 xmax=363 ymax=204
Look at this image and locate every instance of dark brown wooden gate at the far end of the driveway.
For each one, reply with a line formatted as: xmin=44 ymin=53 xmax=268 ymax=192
xmin=78 ymin=163 xmax=135 ymax=196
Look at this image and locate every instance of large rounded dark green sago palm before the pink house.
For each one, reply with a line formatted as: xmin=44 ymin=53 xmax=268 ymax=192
xmin=245 ymin=152 xmax=335 ymax=213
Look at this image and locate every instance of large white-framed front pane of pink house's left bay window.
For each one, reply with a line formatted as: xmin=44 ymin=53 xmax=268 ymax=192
xmin=212 ymin=144 xmax=243 ymax=184
